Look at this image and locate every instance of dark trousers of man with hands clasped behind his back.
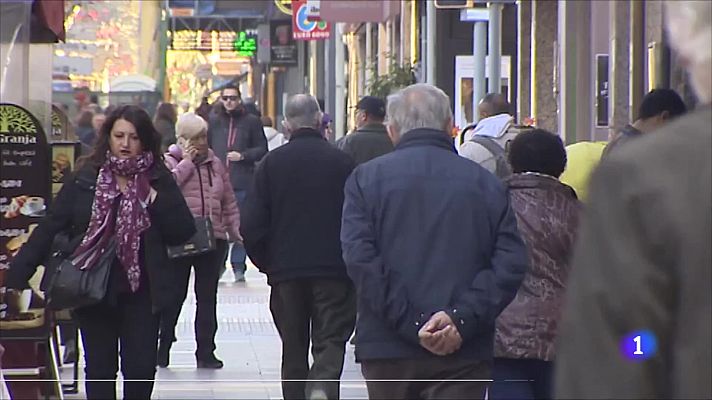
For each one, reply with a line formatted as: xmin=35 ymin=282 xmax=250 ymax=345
xmin=361 ymin=356 xmax=490 ymax=400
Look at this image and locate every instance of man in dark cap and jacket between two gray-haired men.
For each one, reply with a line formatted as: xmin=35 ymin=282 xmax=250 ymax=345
xmin=338 ymin=96 xmax=393 ymax=165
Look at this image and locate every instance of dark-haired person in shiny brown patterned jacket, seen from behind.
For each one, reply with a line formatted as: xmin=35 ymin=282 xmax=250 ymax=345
xmin=489 ymin=129 xmax=580 ymax=400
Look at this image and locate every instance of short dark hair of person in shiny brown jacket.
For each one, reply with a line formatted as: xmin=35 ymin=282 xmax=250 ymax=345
xmin=508 ymin=129 xmax=566 ymax=178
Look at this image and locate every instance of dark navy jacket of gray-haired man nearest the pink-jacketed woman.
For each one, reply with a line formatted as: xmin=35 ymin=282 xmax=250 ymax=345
xmin=240 ymin=128 xmax=354 ymax=285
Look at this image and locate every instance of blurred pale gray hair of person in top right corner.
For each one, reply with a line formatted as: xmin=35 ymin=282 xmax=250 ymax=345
xmin=665 ymin=1 xmax=712 ymax=102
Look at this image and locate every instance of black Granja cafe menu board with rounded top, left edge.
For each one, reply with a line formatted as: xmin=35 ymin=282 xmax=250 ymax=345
xmin=0 ymin=103 xmax=51 ymax=317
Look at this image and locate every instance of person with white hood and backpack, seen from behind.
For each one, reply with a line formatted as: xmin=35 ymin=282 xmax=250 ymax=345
xmin=458 ymin=93 xmax=520 ymax=178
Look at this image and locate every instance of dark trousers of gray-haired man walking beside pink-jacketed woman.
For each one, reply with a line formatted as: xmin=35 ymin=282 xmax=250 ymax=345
xmin=270 ymin=279 xmax=356 ymax=400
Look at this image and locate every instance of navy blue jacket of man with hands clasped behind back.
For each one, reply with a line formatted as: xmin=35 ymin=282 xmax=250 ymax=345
xmin=341 ymin=129 xmax=528 ymax=361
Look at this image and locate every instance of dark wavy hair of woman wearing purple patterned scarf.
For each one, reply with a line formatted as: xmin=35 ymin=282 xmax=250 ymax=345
xmin=77 ymin=105 xmax=162 ymax=169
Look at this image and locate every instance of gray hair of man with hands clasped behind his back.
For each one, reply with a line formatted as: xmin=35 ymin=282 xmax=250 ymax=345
xmin=386 ymin=83 xmax=452 ymax=135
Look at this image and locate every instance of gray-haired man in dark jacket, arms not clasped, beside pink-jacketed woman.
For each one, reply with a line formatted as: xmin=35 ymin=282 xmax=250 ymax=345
xmin=241 ymin=95 xmax=356 ymax=399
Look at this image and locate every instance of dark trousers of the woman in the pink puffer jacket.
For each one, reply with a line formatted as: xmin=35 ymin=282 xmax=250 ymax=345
xmin=160 ymin=240 xmax=227 ymax=359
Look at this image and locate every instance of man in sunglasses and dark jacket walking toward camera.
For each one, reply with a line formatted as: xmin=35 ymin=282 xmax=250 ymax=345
xmin=208 ymin=85 xmax=267 ymax=282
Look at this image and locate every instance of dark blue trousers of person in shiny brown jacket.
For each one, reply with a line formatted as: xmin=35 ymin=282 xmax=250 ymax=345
xmin=489 ymin=358 xmax=553 ymax=400
